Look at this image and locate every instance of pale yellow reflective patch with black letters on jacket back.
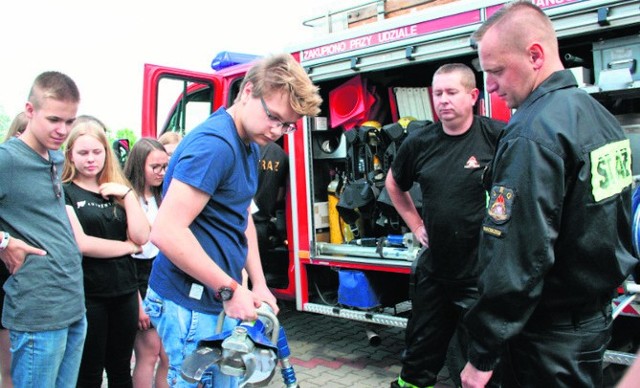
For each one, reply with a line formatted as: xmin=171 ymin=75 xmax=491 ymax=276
xmin=589 ymin=139 xmax=633 ymax=202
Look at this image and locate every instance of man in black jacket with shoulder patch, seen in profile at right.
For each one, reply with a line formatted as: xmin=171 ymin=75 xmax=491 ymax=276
xmin=461 ymin=1 xmax=637 ymax=388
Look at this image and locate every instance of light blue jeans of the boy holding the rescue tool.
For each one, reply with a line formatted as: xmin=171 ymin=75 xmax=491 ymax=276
xmin=144 ymin=288 xmax=238 ymax=388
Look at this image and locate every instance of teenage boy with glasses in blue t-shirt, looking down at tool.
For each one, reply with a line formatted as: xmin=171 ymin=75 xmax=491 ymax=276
xmin=145 ymin=54 xmax=322 ymax=387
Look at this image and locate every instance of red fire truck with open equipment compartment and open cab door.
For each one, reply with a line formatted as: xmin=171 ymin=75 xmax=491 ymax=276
xmin=142 ymin=0 xmax=640 ymax=366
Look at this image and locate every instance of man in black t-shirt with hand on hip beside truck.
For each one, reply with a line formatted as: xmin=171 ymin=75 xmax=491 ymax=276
xmin=386 ymin=64 xmax=505 ymax=388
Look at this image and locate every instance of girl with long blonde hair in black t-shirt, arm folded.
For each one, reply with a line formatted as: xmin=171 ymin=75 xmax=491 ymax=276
xmin=62 ymin=118 xmax=150 ymax=388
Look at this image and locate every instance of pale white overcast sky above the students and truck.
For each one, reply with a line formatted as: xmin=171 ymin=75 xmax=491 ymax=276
xmin=0 ymin=0 xmax=356 ymax=133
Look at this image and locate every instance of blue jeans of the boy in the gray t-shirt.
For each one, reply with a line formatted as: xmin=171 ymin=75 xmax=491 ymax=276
xmin=9 ymin=317 xmax=87 ymax=388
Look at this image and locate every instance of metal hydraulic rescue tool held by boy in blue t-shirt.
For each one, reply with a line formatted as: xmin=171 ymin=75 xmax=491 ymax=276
xmin=181 ymin=303 xmax=298 ymax=388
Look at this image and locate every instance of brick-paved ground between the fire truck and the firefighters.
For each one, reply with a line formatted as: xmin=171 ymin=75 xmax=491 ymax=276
xmin=268 ymin=304 xmax=453 ymax=388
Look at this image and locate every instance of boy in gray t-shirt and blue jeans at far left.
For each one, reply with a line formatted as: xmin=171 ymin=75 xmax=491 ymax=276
xmin=0 ymin=72 xmax=86 ymax=387
